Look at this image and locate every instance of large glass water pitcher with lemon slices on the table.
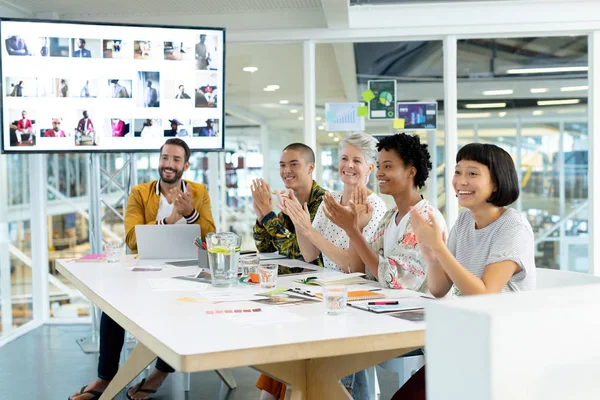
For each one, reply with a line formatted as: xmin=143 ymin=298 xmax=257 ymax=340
xmin=206 ymin=232 xmax=242 ymax=287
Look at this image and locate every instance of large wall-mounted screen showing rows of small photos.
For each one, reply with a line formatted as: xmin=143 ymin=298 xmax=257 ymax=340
xmin=0 ymin=19 xmax=225 ymax=153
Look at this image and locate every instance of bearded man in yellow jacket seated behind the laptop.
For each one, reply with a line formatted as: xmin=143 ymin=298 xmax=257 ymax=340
xmin=70 ymin=138 xmax=216 ymax=400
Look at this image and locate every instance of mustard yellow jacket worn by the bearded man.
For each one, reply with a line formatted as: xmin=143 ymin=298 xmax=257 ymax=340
xmin=125 ymin=181 xmax=216 ymax=253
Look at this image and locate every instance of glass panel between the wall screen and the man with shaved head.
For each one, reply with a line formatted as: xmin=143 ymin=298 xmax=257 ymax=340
xmin=224 ymin=44 xmax=304 ymax=248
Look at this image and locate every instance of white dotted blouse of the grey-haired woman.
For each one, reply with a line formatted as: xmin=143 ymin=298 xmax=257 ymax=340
xmin=313 ymin=192 xmax=387 ymax=272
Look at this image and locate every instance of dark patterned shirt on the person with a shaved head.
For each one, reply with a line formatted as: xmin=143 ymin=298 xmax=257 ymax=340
xmin=254 ymin=181 xmax=327 ymax=265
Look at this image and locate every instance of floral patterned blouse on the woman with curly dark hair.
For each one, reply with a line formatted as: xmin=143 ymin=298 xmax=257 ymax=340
xmin=365 ymin=200 xmax=448 ymax=293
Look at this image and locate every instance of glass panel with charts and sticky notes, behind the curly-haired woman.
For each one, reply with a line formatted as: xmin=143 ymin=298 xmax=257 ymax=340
xmin=316 ymin=41 xmax=445 ymax=210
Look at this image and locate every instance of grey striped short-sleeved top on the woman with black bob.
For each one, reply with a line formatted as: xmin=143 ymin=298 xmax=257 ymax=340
xmin=448 ymin=208 xmax=536 ymax=296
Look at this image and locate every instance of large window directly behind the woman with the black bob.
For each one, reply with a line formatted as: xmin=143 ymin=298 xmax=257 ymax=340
xmin=457 ymin=36 xmax=589 ymax=272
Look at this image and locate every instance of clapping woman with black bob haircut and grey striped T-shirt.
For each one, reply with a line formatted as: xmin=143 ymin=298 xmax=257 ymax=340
xmin=392 ymin=143 xmax=536 ymax=400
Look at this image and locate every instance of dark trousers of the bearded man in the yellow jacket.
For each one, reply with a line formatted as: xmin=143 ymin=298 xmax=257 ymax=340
xmin=98 ymin=313 xmax=175 ymax=380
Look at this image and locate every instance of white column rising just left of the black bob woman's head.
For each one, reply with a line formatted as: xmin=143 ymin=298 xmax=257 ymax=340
xmin=444 ymin=35 xmax=458 ymax=228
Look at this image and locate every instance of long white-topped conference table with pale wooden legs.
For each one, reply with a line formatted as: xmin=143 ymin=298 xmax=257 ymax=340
xmin=57 ymin=259 xmax=425 ymax=400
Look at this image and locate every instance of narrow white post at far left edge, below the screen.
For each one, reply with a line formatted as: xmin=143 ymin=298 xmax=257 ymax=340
xmin=0 ymin=154 xmax=16 ymax=336
